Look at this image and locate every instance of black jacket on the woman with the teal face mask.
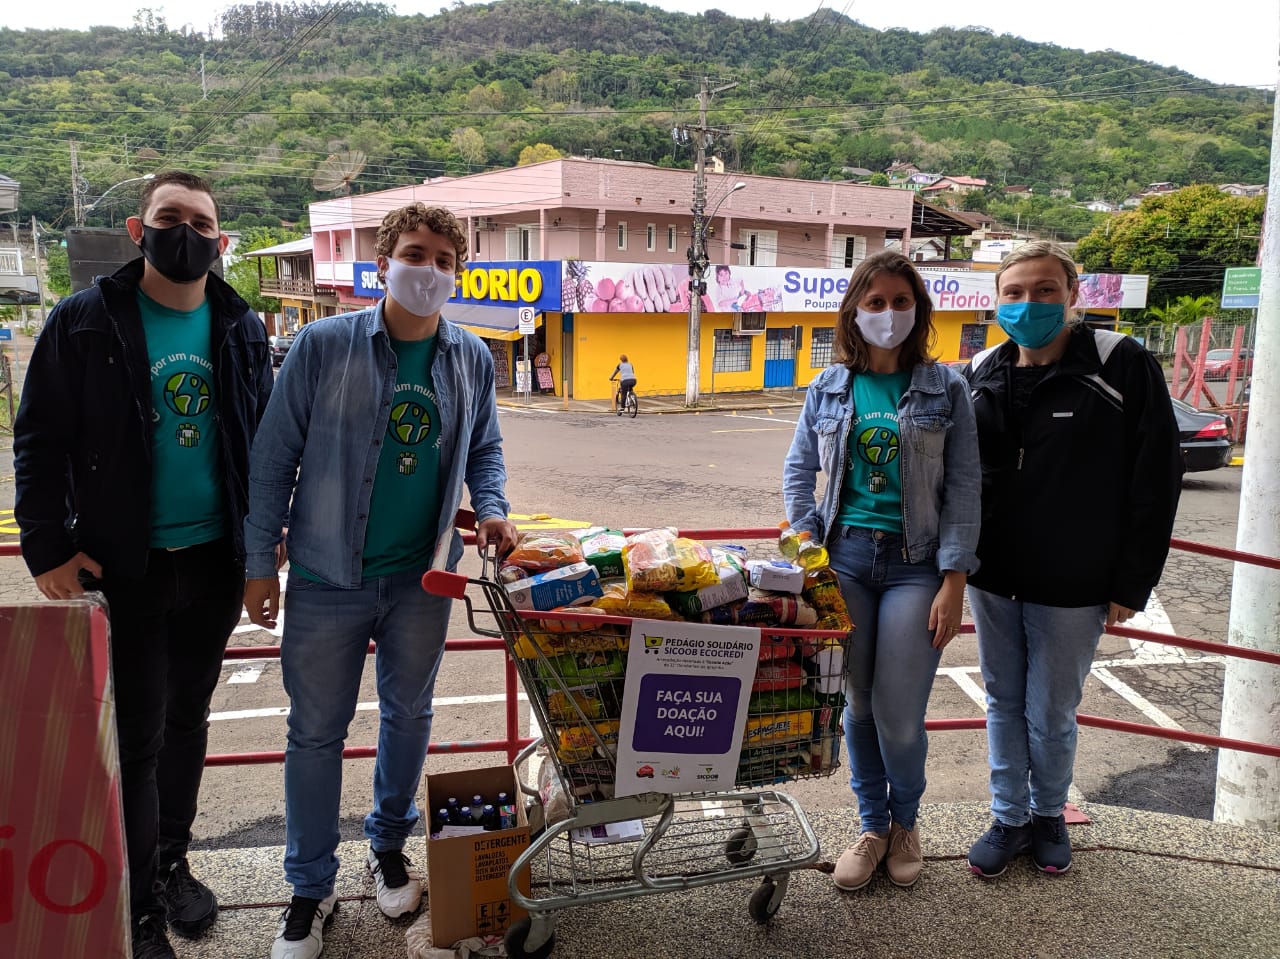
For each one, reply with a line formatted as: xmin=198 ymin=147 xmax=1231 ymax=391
xmin=964 ymin=326 xmax=1183 ymax=609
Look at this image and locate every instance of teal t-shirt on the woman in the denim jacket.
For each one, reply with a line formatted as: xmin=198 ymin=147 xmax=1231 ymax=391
xmin=836 ymin=371 xmax=911 ymax=535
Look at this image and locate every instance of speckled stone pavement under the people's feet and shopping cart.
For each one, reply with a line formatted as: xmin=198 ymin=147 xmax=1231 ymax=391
xmin=174 ymin=803 xmax=1280 ymax=959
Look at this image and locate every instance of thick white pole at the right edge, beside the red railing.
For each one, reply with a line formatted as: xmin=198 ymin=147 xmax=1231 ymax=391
xmin=1213 ymin=23 xmax=1280 ymax=832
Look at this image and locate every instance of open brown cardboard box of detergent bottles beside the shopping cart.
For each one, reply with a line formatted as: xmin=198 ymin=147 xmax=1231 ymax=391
xmin=422 ymin=766 xmax=529 ymax=949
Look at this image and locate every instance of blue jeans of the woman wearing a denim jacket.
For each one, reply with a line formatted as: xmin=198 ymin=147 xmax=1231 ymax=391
xmin=827 ymin=526 xmax=942 ymax=834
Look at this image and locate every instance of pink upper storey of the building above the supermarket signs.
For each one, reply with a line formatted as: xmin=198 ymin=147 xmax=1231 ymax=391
xmin=311 ymin=157 xmax=973 ymax=307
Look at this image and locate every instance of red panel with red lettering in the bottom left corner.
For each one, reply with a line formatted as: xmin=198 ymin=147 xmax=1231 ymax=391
xmin=0 ymin=594 xmax=129 ymax=959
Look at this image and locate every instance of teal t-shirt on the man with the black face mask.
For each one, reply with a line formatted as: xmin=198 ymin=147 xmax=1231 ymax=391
xmin=138 ymin=289 xmax=228 ymax=548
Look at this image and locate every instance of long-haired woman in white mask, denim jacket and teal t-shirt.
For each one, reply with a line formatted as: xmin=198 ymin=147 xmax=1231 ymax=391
xmin=783 ymin=251 xmax=980 ymax=890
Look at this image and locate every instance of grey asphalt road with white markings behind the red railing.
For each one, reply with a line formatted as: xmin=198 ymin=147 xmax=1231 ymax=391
xmin=0 ymin=384 xmax=1240 ymax=846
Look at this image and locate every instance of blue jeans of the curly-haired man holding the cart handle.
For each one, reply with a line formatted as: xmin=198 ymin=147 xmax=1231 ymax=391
xmin=280 ymin=571 xmax=449 ymax=899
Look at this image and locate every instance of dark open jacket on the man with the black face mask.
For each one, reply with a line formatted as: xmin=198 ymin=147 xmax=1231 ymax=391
xmin=13 ymin=259 xmax=273 ymax=577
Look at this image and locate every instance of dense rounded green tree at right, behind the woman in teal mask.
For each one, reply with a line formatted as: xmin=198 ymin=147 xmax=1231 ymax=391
xmin=1075 ymin=184 xmax=1266 ymax=302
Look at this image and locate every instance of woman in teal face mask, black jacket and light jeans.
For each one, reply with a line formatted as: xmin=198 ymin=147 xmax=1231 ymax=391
xmin=965 ymin=242 xmax=1183 ymax=877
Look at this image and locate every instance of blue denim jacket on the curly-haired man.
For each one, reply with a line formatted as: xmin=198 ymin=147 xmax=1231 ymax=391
xmin=244 ymin=303 xmax=509 ymax=588
